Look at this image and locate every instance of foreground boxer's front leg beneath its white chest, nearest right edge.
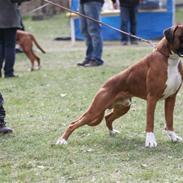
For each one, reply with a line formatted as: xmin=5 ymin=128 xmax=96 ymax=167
xmin=165 ymin=95 xmax=182 ymax=142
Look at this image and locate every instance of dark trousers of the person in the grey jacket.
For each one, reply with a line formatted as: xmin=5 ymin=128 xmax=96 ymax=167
xmin=0 ymin=28 xmax=16 ymax=76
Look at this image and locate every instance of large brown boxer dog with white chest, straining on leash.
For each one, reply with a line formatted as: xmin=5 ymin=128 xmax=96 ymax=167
xmin=56 ymin=25 xmax=183 ymax=147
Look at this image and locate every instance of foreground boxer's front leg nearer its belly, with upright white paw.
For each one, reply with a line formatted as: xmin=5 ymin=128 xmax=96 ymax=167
xmin=145 ymin=96 xmax=157 ymax=147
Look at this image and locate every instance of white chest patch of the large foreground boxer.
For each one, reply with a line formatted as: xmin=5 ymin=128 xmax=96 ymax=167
xmin=163 ymin=56 xmax=182 ymax=99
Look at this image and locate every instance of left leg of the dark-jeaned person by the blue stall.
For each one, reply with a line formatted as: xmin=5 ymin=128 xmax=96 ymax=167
xmin=120 ymin=7 xmax=129 ymax=44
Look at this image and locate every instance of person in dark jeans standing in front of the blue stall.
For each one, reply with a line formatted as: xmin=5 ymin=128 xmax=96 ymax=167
xmin=112 ymin=0 xmax=140 ymax=45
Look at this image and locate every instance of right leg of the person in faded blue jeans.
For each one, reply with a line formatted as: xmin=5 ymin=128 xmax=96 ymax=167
xmin=84 ymin=2 xmax=103 ymax=65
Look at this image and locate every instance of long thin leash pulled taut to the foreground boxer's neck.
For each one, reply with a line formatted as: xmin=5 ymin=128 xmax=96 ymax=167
xmin=31 ymin=0 xmax=156 ymax=48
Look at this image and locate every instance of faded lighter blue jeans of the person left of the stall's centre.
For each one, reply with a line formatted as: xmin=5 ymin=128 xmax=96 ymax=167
xmin=79 ymin=2 xmax=103 ymax=64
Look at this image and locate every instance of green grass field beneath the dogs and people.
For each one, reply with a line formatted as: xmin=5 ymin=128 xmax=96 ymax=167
xmin=0 ymin=12 xmax=183 ymax=183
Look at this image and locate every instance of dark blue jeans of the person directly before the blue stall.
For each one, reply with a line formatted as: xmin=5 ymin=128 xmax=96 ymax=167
xmin=120 ymin=6 xmax=137 ymax=41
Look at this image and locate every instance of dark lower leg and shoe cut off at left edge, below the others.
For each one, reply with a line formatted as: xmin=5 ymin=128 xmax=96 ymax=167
xmin=0 ymin=93 xmax=13 ymax=133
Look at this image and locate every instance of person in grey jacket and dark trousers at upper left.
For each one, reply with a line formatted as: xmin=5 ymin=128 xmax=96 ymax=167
xmin=0 ymin=0 xmax=21 ymax=78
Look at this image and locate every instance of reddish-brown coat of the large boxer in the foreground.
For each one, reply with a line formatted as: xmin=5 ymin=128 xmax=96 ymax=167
xmin=57 ymin=26 xmax=183 ymax=147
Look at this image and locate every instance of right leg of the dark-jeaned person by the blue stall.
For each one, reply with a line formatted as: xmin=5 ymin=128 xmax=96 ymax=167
xmin=130 ymin=7 xmax=137 ymax=44
